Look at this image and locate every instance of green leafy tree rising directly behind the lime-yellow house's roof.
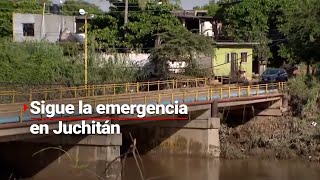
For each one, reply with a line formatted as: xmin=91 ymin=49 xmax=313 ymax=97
xmin=218 ymin=0 xmax=288 ymax=61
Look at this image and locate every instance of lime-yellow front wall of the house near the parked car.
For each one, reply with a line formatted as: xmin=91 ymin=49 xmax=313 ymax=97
xmin=212 ymin=47 xmax=252 ymax=79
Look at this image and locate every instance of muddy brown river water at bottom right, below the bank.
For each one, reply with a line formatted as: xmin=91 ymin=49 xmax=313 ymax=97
xmin=123 ymin=156 xmax=320 ymax=180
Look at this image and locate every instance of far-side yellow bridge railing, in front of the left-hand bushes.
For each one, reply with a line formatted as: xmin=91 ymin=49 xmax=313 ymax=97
xmin=0 ymin=78 xmax=208 ymax=104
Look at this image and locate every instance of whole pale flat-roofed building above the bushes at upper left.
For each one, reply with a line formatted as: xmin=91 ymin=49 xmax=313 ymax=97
xmin=12 ymin=13 xmax=91 ymax=43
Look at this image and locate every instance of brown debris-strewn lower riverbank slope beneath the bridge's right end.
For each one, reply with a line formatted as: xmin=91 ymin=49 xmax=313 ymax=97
xmin=220 ymin=115 xmax=320 ymax=162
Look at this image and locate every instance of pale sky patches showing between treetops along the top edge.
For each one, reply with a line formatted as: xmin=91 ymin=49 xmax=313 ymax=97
xmin=53 ymin=0 xmax=209 ymax=11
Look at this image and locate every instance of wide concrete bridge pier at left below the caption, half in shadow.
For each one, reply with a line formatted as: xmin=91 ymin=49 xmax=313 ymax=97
xmin=2 ymin=134 xmax=122 ymax=180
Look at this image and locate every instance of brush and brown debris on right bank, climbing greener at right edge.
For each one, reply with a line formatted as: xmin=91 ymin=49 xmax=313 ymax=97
xmin=220 ymin=75 xmax=320 ymax=162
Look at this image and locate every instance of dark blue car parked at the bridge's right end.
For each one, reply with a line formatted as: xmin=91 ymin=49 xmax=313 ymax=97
xmin=260 ymin=68 xmax=288 ymax=83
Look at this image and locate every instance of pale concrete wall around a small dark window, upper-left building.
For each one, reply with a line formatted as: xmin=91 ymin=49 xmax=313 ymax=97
xmin=13 ymin=13 xmax=76 ymax=42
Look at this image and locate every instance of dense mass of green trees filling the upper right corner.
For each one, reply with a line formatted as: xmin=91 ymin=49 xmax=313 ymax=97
xmin=197 ymin=0 xmax=320 ymax=66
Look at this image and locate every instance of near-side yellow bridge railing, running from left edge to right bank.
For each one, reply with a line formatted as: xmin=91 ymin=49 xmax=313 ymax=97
xmin=0 ymin=82 xmax=287 ymax=124
